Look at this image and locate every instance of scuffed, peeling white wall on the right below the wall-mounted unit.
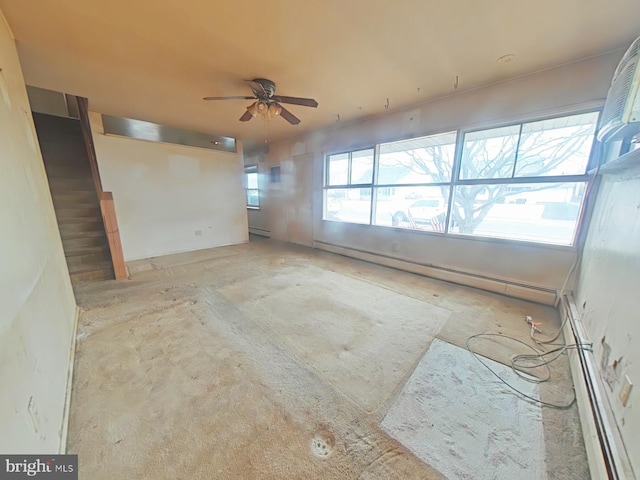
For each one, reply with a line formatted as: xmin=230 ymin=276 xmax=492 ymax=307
xmin=575 ymin=169 xmax=640 ymax=476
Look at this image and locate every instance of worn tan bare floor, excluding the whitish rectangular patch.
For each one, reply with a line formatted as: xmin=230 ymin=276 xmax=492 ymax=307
xmin=68 ymin=240 xmax=589 ymax=480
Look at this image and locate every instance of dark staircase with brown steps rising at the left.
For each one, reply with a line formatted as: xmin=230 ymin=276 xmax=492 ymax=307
xmin=33 ymin=113 xmax=115 ymax=285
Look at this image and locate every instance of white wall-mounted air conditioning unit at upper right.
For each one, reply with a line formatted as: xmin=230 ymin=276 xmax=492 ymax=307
xmin=598 ymin=37 xmax=640 ymax=142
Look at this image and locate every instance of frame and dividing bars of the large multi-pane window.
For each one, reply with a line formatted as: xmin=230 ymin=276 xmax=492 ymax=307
xmin=322 ymin=103 xmax=602 ymax=250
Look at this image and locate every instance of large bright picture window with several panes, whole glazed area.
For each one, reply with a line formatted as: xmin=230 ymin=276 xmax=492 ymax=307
xmin=323 ymin=112 xmax=598 ymax=245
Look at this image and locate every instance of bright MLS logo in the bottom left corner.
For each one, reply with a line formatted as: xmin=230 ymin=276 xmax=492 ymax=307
xmin=0 ymin=455 xmax=78 ymax=480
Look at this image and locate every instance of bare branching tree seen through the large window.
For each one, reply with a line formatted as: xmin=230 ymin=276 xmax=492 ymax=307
xmin=397 ymin=116 xmax=597 ymax=234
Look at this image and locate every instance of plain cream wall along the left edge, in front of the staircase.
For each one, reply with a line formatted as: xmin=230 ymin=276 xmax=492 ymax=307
xmin=0 ymin=12 xmax=76 ymax=453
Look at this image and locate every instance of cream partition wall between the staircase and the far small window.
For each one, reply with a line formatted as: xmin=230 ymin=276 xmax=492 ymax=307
xmin=90 ymin=112 xmax=248 ymax=261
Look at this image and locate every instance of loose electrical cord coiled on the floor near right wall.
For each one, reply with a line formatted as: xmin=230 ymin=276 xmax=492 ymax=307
xmin=466 ymin=333 xmax=590 ymax=410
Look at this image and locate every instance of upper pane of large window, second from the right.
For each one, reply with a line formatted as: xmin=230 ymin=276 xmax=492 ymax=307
xmin=460 ymin=125 xmax=520 ymax=180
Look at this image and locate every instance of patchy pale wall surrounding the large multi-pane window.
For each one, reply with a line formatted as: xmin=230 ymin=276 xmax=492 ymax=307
xmin=262 ymin=51 xmax=624 ymax=301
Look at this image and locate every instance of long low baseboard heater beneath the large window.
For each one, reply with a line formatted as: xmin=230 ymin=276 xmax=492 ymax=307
xmin=313 ymin=241 xmax=556 ymax=305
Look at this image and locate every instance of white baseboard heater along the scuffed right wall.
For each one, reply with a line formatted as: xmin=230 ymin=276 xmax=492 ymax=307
xmin=560 ymin=294 xmax=636 ymax=480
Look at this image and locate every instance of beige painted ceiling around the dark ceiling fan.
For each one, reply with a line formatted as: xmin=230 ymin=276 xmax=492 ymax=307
xmin=0 ymin=0 xmax=640 ymax=147
